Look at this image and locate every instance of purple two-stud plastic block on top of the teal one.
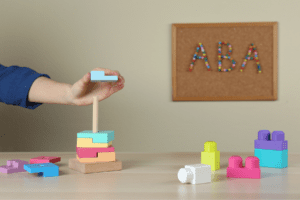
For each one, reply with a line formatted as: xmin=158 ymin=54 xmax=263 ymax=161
xmin=254 ymin=130 xmax=288 ymax=151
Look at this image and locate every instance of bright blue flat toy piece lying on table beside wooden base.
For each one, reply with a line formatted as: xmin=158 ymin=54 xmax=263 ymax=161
xmin=24 ymin=163 xmax=59 ymax=177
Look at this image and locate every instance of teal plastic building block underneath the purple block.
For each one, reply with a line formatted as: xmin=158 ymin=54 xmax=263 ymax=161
xmin=254 ymin=149 xmax=288 ymax=168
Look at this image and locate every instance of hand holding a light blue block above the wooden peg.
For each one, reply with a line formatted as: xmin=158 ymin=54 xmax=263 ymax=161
xmin=67 ymin=68 xmax=125 ymax=106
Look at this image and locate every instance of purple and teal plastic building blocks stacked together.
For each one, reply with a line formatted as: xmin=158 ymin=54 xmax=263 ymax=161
xmin=254 ymin=130 xmax=288 ymax=168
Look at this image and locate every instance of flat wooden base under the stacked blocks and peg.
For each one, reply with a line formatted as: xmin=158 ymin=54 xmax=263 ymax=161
xmin=69 ymin=158 xmax=122 ymax=174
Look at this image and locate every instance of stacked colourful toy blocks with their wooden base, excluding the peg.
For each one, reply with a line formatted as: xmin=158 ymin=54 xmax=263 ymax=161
xmin=69 ymin=131 xmax=122 ymax=173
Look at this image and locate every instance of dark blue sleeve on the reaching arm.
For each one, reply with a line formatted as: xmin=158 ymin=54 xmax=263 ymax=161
xmin=0 ymin=64 xmax=50 ymax=110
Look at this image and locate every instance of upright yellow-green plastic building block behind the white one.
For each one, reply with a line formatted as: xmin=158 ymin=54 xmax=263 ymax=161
xmin=201 ymin=141 xmax=220 ymax=171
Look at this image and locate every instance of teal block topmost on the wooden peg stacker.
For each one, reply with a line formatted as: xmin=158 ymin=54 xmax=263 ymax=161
xmin=77 ymin=130 xmax=115 ymax=143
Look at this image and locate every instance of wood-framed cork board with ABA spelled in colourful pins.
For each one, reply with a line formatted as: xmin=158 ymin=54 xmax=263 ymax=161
xmin=172 ymin=22 xmax=278 ymax=101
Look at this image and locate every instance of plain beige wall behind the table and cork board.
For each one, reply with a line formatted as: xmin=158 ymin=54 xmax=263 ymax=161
xmin=0 ymin=0 xmax=300 ymax=153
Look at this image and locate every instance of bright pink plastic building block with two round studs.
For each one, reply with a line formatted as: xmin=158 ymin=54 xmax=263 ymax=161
xmin=227 ymin=156 xmax=260 ymax=179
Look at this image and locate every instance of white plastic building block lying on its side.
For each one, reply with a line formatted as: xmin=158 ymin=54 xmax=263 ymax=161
xmin=177 ymin=164 xmax=211 ymax=184
